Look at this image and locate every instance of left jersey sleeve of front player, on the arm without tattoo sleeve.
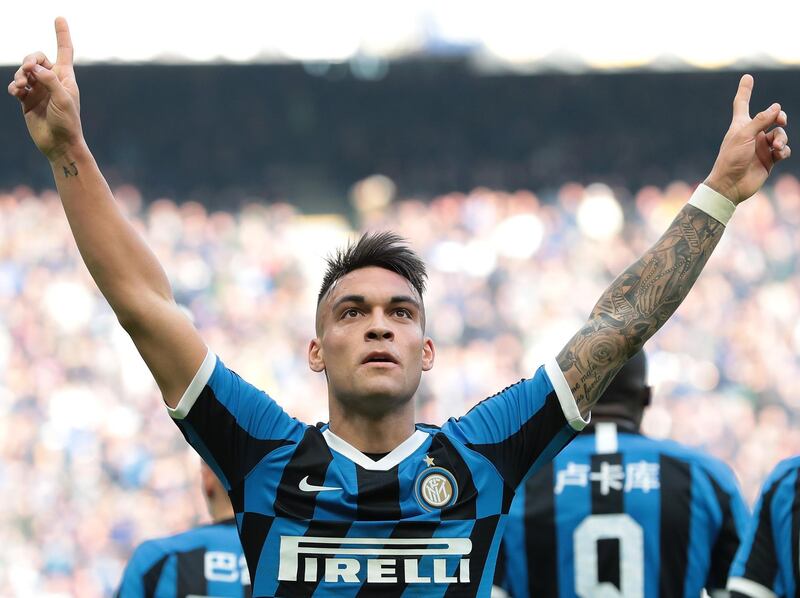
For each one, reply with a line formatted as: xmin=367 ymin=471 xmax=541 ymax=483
xmin=167 ymin=351 xmax=305 ymax=491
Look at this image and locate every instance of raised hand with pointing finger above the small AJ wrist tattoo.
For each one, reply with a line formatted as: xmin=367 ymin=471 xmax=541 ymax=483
xmin=8 ymin=17 xmax=83 ymax=161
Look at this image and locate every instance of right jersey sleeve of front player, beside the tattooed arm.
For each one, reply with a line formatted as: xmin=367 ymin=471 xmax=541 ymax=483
xmin=442 ymin=359 xmax=589 ymax=488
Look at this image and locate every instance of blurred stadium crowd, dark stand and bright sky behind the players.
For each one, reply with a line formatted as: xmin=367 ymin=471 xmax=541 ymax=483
xmin=0 ymin=0 xmax=800 ymax=598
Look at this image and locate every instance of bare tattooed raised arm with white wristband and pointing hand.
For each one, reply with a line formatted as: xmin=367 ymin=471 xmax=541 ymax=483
xmin=557 ymin=75 xmax=791 ymax=416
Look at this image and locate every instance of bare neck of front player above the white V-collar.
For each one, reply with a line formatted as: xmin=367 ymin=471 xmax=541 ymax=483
xmin=329 ymin=399 xmax=414 ymax=453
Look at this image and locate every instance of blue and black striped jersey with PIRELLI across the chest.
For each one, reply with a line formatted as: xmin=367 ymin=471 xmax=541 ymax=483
xmin=170 ymin=353 xmax=585 ymax=598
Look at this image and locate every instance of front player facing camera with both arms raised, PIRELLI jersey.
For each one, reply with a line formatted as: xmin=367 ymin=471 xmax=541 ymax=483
xmin=8 ymin=19 xmax=790 ymax=596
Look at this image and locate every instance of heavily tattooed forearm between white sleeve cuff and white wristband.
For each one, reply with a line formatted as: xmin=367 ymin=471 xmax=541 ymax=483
xmin=557 ymin=205 xmax=725 ymax=413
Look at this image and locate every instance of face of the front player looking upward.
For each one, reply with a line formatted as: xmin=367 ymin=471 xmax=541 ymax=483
xmin=308 ymin=267 xmax=434 ymax=415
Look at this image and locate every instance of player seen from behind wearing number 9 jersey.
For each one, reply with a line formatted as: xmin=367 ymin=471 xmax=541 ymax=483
xmin=496 ymin=352 xmax=748 ymax=598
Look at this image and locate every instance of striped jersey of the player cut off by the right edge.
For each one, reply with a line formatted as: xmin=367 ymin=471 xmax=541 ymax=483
xmin=728 ymin=457 xmax=800 ymax=598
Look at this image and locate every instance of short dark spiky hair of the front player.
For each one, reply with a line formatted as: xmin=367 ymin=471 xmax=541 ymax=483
xmin=317 ymin=231 xmax=428 ymax=305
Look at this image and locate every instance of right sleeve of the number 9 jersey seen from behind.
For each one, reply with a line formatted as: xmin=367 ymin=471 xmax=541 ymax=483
xmin=706 ymin=463 xmax=750 ymax=595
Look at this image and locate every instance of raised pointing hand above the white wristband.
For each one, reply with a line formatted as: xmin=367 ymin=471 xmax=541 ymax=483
xmin=705 ymin=75 xmax=792 ymax=204
